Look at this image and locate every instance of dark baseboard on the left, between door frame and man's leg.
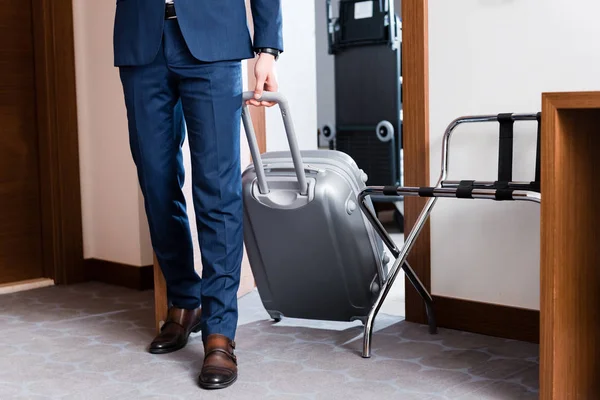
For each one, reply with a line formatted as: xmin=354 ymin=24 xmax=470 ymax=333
xmin=85 ymin=258 xmax=154 ymax=290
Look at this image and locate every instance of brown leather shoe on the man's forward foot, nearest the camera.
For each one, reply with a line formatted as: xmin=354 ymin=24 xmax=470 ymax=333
xmin=198 ymin=334 xmax=237 ymax=389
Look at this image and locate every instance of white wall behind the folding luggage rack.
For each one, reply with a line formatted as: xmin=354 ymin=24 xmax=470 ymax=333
xmin=428 ymin=0 xmax=600 ymax=309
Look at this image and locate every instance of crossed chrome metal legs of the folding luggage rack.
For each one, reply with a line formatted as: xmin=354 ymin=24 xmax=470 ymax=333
xmin=358 ymin=188 xmax=437 ymax=358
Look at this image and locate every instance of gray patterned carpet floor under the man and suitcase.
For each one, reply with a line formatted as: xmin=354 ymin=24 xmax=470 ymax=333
xmin=0 ymin=283 xmax=538 ymax=400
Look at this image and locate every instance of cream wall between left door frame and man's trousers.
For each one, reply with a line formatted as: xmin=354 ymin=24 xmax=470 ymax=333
xmin=73 ymin=0 xmax=152 ymax=265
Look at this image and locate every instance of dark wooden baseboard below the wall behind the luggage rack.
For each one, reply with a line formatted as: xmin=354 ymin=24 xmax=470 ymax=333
xmin=433 ymin=296 xmax=540 ymax=343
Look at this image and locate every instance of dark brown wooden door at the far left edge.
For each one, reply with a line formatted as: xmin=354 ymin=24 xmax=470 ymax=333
xmin=0 ymin=0 xmax=44 ymax=284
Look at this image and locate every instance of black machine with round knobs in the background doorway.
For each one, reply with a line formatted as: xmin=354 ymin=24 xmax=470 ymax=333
xmin=321 ymin=0 xmax=404 ymax=228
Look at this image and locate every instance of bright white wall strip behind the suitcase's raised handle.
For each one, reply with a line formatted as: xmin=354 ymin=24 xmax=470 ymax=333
xmin=266 ymin=1 xmax=317 ymax=151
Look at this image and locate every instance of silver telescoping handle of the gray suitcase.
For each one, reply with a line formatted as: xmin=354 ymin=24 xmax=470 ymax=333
xmin=242 ymin=91 xmax=308 ymax=195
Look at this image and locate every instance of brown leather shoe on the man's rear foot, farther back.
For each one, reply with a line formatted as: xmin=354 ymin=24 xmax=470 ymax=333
xmin=149 ymin=307 xmax=202 ymax=354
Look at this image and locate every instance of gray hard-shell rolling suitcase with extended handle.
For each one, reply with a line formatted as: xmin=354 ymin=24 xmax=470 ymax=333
xmin=242 ymin=92 xmax=388 ymax=323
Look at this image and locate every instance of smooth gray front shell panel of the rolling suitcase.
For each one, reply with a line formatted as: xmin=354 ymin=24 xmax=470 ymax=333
xmin=244 ymin=161 xmax=380 ymax=320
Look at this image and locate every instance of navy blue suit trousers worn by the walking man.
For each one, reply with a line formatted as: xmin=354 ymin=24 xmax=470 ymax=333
xmin=119 ymin=19 xmax=243 ymax=339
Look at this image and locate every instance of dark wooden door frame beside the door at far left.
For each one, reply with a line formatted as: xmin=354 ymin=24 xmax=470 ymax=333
xmin=31 ymin=0 xmax=85 ymax=284
